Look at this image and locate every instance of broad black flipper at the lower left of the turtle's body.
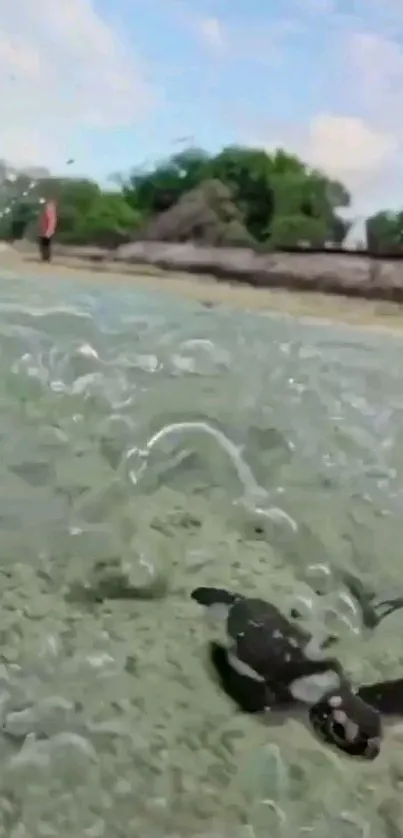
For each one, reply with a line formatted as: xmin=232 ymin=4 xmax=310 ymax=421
xmin=209 ymin=642 xmax=266 ymax=713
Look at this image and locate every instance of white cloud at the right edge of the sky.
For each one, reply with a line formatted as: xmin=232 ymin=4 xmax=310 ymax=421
xmin=330 ymin=28 xmax=403 ymax=209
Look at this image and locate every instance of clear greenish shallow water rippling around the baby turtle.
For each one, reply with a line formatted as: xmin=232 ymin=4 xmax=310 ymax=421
xmin=0 ymin=277 xmax=403 ymax=838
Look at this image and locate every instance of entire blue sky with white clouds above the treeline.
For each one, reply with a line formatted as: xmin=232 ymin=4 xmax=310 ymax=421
xmin=0 ymin=0 xmax=403 ymax=217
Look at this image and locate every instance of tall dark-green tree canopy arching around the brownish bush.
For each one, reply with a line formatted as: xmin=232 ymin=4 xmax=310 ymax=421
xmin=123 ymin=146 xmax=350 ymax=246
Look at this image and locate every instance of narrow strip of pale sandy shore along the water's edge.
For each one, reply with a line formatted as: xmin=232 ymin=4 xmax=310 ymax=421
xmin=0 ymin=253 xmax=403 ymax=332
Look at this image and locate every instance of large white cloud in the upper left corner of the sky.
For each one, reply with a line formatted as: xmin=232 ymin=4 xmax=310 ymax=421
xmin=0 ymin=0 xmax=158 ymax=165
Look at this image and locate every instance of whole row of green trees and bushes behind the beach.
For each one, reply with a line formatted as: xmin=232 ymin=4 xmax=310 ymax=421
xmin=0 ymin=146 xmax=403 ymax=250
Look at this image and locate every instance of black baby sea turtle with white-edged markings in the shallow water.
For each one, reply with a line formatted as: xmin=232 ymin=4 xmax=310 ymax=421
xmin=191 ymin=587 xmax=382 ymax=760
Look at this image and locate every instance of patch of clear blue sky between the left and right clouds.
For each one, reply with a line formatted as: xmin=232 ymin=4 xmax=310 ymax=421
xmin=72 ymin=0 xmax=344 ymax=173
